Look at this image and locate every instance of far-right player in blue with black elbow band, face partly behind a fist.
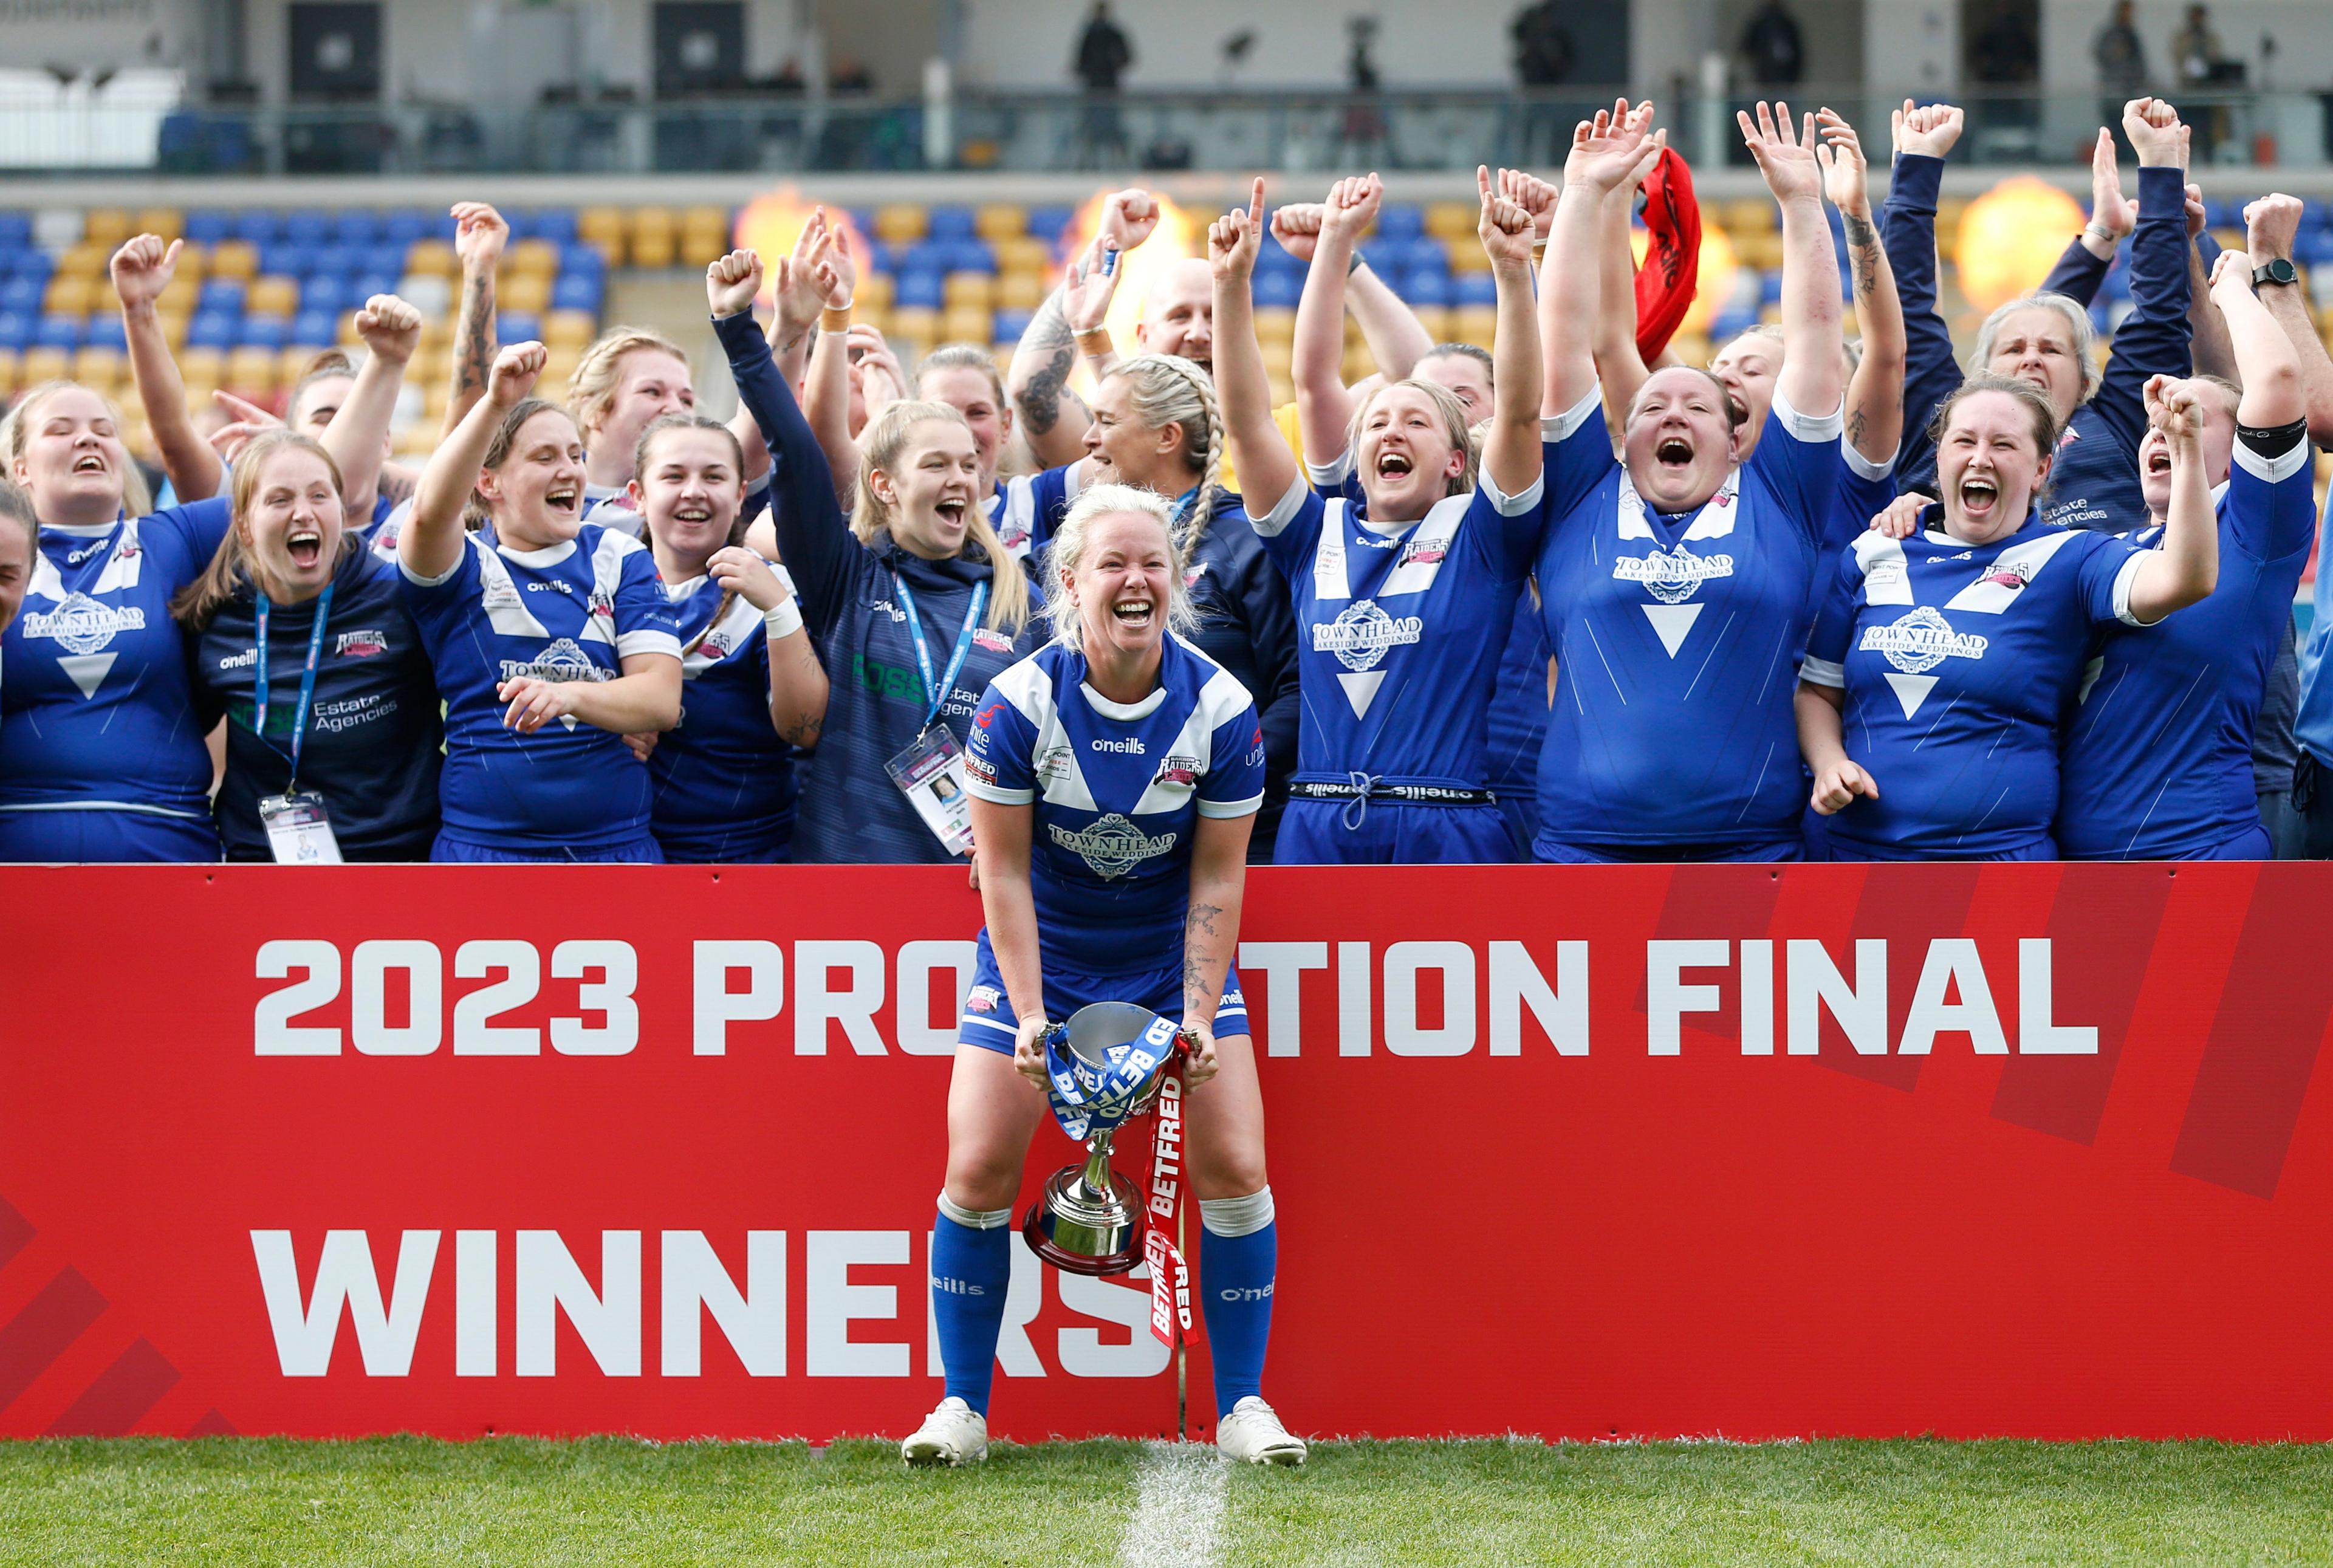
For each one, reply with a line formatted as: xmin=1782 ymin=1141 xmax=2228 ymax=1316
xmin=2058 ymin=250 xmax=2317 ymax=861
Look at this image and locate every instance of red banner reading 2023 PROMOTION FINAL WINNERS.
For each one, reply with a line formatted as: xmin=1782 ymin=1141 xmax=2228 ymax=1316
xmin=0 ymin=863 xmax=2333 ymax=1440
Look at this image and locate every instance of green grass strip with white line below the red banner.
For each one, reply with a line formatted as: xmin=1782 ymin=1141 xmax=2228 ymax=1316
xmin=0 ymin=1437 xmax=2333 ymax=1568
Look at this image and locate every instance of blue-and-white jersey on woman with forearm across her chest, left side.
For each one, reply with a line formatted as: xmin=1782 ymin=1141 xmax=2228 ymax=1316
xmin=399 ymin=522 xmax=681 ymax=854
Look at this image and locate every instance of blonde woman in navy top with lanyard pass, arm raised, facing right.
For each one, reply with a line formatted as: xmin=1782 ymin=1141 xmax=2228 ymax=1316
xmin=714 ymin=249 xmax=1033 ymax=863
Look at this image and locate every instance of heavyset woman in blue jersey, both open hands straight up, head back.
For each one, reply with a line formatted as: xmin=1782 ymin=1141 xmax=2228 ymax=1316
xmin=1533 ymin=103 xmax=1845 ymax=863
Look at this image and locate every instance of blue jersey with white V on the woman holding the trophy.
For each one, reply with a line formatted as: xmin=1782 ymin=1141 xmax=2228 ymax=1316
xmin=964 ymin=635 xmax=1264 ymax=975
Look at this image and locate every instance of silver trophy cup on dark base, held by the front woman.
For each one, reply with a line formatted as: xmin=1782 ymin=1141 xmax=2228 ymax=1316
xmin=1022 ymin=1001 xmax=1180 ymax=1274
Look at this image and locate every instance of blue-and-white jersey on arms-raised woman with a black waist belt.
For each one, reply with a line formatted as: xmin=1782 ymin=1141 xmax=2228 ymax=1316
xmin=1250 ymin=450 xmax=1544 ymax=863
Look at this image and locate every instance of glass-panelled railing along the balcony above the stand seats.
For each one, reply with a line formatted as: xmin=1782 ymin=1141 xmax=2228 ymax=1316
xmin=0 ymin=84 xmax=2333 ymax=175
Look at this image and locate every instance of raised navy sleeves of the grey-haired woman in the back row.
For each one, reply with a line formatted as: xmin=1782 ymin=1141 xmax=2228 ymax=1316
xmin=1880 ymin=152 xmax=2193 ymax=532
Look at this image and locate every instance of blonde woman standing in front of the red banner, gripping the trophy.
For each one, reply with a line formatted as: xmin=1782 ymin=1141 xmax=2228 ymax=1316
xmin=900 ymin=485 xmax=1304 ymax=1465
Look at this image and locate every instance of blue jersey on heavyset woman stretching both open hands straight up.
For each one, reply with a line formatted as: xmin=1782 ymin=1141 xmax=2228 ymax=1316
xmin=1533 ymin=394 xmax=1843 ymax=858
